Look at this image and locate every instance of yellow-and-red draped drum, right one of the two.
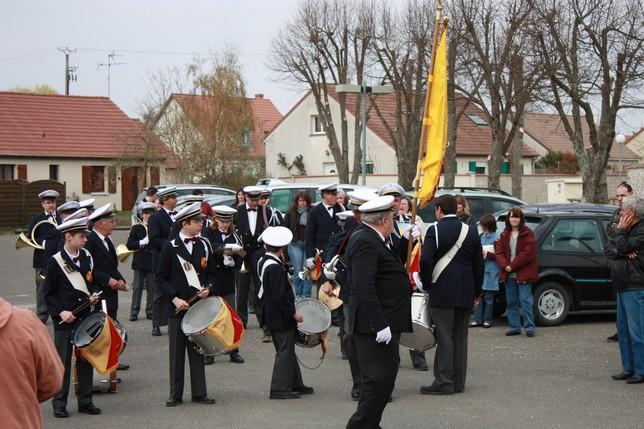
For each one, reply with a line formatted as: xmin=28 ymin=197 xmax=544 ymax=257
xmin=181 ymin=296 xmax=244 ymax=356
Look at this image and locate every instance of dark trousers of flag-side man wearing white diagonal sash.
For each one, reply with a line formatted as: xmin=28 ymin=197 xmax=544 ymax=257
xmin=431 ymin=307 xmax=472 ymax=392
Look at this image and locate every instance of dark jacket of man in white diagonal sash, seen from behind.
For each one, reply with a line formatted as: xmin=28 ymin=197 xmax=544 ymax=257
xmin=420 ymin=216 xmax=485 ymax=308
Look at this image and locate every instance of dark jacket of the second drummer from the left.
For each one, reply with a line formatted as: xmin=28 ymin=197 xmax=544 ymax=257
xmin=156 ymin=237 xmax=215 ymax=319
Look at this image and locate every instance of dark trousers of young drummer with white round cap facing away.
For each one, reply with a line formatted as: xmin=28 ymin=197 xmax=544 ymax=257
xmin=271 ymin=328 xmax=304 ymax=392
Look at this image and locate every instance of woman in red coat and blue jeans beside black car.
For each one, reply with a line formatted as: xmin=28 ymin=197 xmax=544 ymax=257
xmin=494 ymin=207 xmax=538 ymax=337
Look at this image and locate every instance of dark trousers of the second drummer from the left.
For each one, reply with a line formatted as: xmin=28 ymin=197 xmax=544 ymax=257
xmin=168 ymin=317 xmax=207 ymax=399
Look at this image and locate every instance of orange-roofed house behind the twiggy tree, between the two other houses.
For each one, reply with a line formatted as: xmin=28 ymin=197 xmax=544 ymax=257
xmin=152 ymin=94 xmax=282 ymax=181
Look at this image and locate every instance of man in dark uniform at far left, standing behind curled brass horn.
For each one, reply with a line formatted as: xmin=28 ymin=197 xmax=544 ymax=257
xmin=27 ymin=189 xmax=58 ymax=323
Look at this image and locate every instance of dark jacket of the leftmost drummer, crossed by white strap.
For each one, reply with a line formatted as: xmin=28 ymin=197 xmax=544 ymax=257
xmin=43 ymin=249 xmax=100 ymax=331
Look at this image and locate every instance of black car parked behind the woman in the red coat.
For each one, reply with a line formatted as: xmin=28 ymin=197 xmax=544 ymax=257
xmin=495 ymin=204 xmax=617 ymax=326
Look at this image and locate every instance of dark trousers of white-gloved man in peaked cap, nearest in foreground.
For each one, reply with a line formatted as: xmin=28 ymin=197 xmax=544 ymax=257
xmin=347 ymin=334 xmax=400 ymax=429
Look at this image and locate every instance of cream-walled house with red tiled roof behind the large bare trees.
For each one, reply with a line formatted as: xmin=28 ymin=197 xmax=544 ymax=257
xmin=264 ymin=86 xmax=538 ymax=182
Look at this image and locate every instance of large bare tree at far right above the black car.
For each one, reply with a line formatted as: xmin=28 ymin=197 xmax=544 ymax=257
xmin=536 ymin=0 xmax=644 ymax=203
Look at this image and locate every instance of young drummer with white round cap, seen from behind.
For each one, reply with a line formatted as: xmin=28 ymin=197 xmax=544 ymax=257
xmin=257 ymin=226 xmax=313 ymax=399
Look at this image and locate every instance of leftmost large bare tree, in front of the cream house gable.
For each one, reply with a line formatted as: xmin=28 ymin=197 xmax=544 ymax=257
xmin=270 ymin=0 xmax=373 ymax=183
